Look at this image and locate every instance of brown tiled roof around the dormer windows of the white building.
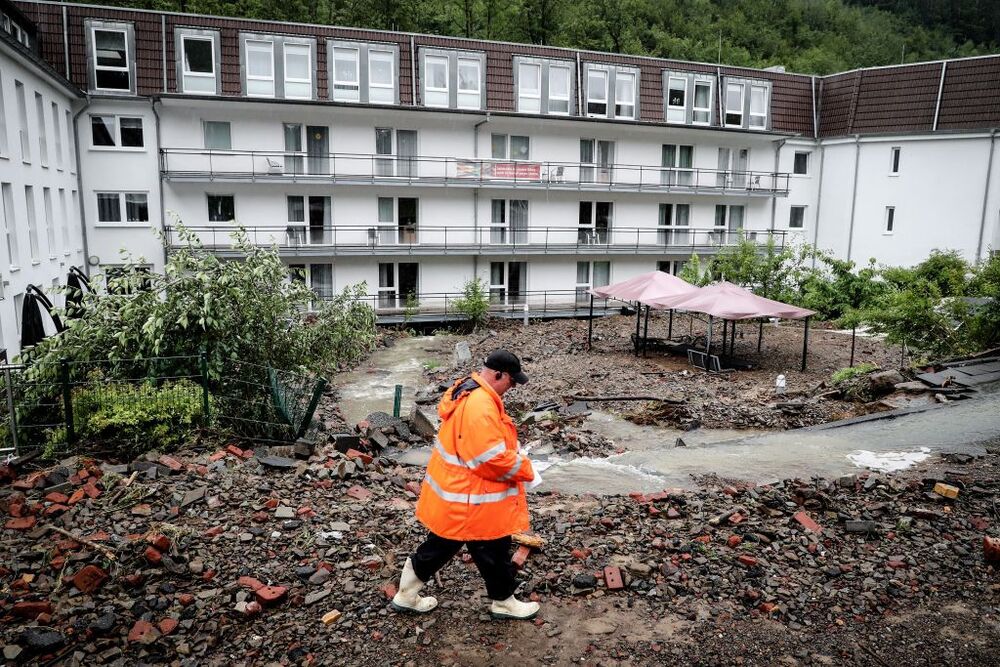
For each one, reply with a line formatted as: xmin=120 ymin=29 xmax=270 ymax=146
xmin=16 ymin=0 xmax=1000 ymax=137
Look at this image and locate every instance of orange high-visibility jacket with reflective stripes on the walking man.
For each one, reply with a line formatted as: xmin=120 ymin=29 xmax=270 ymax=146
xmin=417 ymin=373 xmax=535 ymax=542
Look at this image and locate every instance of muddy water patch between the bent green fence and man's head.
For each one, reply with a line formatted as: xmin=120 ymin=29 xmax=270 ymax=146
xmin=334 ymin=336 xmax=457 ymax=424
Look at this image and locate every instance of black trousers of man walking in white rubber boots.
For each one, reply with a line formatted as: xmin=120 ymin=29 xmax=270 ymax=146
xmin=410 ymin=533 xmax=515 ymax=600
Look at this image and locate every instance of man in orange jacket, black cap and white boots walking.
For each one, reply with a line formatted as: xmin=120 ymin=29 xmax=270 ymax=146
xmin=392 ymin=350 xmax=538 ymax=619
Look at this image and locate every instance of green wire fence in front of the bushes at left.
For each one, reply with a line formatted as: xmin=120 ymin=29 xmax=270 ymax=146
xmin=0 ymin=355 xmax=326 ymax=456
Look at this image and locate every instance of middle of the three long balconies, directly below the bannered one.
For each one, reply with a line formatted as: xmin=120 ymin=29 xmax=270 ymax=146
xmin=165 ymin=224 xmax=786 ymax=257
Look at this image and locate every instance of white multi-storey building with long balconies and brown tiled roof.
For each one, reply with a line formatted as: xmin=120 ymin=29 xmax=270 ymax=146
xmin=0 ymin=2 xmax=1000 ymax=360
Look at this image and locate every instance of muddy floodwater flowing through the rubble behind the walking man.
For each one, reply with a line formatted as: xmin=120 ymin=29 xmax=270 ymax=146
xmin=336 ymin=336 xmax=1000 ymax=494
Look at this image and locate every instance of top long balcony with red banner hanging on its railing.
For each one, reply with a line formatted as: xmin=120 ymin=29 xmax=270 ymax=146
xmin=160 ymin=148 xmax=790 ymax=197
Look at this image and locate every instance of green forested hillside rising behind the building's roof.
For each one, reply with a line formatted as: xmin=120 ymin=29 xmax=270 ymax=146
xmin=72 ymin=0 xmax=1000 ymax=74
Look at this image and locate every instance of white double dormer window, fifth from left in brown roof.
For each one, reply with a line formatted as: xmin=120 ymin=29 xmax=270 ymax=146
xmin=419 ymin=49 xmax=486 ymax=110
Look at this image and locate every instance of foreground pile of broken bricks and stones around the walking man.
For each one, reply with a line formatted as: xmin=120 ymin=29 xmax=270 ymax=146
xmin=0 ymin=443 xmax=1000 ymax=665
